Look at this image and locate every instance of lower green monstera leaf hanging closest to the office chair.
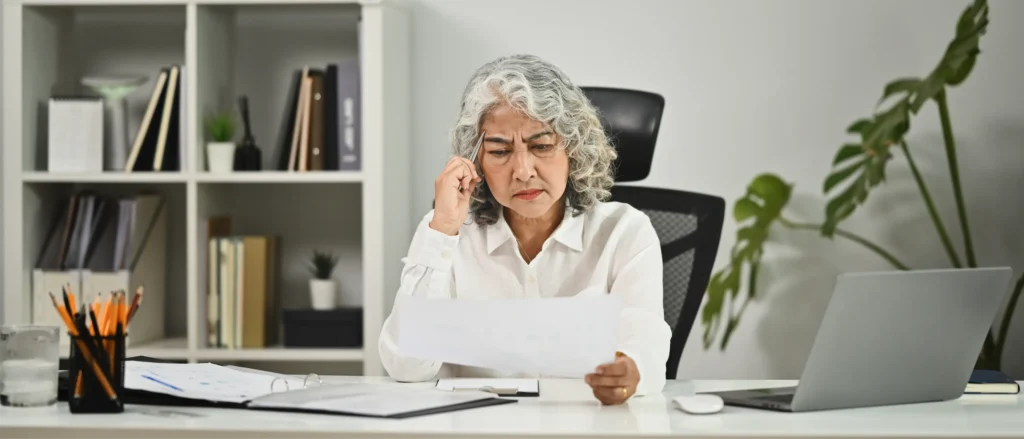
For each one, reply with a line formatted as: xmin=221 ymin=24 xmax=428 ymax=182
xmin=701 ymin=174 xmax=793 ymax=349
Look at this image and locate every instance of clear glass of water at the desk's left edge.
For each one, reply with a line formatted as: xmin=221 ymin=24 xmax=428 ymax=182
xmin=0 ymin=324 xmax=60 ymax=407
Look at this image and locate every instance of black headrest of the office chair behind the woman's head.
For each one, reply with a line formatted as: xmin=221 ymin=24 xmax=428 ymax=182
xmin=581 ymin=87 xmax=665 ymax=182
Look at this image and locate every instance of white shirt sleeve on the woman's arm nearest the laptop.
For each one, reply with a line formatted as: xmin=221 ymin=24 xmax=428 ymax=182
xmin=609 ymin=215 xmax=672 ymax=396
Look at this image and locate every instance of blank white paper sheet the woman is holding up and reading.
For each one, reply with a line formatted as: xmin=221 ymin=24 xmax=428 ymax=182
xmin=398 ymin=294 xmax=623 ymax=378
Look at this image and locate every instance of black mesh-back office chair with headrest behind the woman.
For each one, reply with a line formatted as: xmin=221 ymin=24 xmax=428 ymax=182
xmin=582 ymin=87 xmax=725 ymax=380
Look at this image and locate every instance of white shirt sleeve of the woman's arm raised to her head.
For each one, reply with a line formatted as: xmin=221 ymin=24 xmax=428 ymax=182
xmin=378 ymin=211 xmax=459 ymax=382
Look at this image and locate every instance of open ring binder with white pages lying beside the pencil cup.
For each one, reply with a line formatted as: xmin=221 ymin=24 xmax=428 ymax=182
xmin=61 ymin=358 xmax=516 ymax=419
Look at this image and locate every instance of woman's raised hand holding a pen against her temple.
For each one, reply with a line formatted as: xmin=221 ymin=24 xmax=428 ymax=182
xmin=430 ymin=157 xmax=481 ymax=236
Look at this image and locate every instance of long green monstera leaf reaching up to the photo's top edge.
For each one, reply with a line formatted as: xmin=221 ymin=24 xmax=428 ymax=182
xmin=821 ymin=0 xmax=988 ymax=237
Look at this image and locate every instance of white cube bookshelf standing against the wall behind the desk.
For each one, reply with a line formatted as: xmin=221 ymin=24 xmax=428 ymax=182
xmin=0 ymin=0 xmax=414 ymax=375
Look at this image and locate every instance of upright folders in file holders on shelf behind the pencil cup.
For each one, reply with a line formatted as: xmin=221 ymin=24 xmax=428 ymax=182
xmin=31 ymin=191 xmax=167 ymax=353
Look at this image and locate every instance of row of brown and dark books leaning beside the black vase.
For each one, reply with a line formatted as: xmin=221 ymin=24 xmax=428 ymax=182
xmin=278 ymin=59 xmax=361 ymax=172
